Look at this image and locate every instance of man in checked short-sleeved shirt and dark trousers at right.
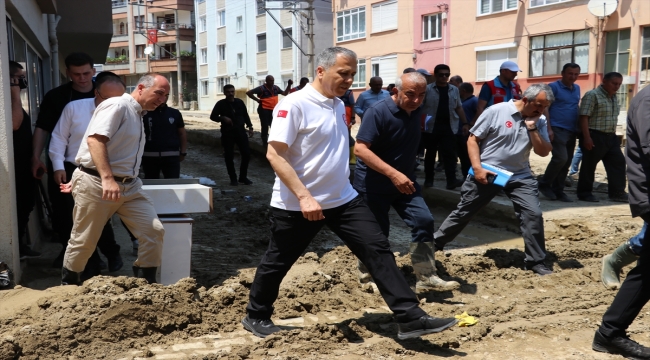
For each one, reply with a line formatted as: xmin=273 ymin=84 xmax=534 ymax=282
xmin=576 ymin=72 xmax=628 ymax=203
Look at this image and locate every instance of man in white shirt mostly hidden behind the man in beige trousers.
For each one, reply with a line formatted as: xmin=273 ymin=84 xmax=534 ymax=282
xmin=49 ymin=71 xmax=126 ymax=280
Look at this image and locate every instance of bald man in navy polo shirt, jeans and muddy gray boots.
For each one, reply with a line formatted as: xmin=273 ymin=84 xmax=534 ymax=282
xmin=354 ymin=72 xmax=460 ymax=292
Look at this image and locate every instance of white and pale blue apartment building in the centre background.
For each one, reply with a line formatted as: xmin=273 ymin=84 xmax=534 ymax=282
xmin=195 ymin=0 xmax=332 ymax=112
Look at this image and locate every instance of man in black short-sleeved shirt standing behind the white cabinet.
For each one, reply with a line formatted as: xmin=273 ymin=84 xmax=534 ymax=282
xmin=142 ymin=104 xmax=187 ymax=179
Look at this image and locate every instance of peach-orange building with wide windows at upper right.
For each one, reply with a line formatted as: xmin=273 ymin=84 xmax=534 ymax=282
xmin=450 ymin=0 xmax=650 ymax=112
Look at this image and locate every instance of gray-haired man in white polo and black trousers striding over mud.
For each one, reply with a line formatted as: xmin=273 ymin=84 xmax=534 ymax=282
xmin=242 ymin=47 xmax=457 ymax=339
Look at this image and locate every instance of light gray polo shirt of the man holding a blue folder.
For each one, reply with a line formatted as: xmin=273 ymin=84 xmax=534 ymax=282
xmin=470 ymin=100 xmax=550 ymax=180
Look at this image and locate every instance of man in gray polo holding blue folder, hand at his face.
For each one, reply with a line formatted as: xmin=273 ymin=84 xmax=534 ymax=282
xmin=434 ymin=84 xmax=554 ymax=275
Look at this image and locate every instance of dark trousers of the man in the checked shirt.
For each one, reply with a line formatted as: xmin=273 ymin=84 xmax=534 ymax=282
xmin=576 ymin=130 xmax=625 ymax=198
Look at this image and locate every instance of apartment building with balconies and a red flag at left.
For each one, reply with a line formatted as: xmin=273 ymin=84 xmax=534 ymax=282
xmin=102 ymin=0 xmax=196 ymax=106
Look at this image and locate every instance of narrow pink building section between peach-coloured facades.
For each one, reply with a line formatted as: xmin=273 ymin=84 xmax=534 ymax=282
xmin=413 ymin=0 xmax=448 ymax=74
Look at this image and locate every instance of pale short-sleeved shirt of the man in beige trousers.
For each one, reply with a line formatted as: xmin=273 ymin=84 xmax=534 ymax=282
xmin=76 ymin=94 xmax=146 ymax=177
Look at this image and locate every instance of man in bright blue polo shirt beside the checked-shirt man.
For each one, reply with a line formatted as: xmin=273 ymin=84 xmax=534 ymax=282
xmin=539 ymin=63 xmax=580 ymax=202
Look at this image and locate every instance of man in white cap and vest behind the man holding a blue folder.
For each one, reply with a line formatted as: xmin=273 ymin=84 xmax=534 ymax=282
xmin=472 ymin=61 xmax=521 ymax=124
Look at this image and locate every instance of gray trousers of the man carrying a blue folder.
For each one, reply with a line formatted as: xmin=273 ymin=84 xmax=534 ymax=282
xmin=433 ymin=175 xmax=546 ymax=263
